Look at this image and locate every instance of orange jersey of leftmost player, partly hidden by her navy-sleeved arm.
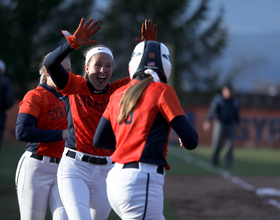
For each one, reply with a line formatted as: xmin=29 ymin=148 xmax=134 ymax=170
xmin=19 ymin=85 xmax=67 ymax=158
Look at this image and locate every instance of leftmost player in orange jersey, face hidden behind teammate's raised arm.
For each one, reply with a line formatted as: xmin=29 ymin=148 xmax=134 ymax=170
xmin=15 ymin=54 xmax=71 ymax=220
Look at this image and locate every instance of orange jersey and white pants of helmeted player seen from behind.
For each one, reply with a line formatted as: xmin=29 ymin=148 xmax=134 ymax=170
xmin=95 ymin=80 xmax=197 ymax=219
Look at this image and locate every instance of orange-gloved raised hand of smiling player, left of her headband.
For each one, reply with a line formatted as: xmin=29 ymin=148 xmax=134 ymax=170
xmin=61 ymin=18 xmax=101 ymax=50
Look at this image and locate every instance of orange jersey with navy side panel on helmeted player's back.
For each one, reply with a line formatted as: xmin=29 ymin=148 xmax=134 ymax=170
xmin=103 ymin=80 xmax=185 ymax=166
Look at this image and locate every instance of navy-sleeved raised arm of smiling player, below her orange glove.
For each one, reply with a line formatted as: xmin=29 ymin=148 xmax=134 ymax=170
xmin=44 ymin=42 xmax=73 ymax=89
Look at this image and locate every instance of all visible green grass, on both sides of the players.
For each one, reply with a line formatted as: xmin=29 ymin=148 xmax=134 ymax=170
xmin=0 ymin=141 xmax=280 ymax=220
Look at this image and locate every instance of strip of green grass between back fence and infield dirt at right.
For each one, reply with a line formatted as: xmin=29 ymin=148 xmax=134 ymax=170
xmin=167 ymin=146 xmax=280 ymax=176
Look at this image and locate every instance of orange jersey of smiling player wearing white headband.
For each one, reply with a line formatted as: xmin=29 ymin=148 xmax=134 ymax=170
xmin=60 ymin=72 xmax=130 ymax=156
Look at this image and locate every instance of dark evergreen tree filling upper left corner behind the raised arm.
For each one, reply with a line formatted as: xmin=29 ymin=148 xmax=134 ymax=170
xmin=0 ymin=0 xmax=94 ymax=98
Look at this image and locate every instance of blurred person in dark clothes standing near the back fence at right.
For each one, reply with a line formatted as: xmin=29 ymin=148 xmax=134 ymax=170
xmin=203 ymin=84 xmax=239 ymax=168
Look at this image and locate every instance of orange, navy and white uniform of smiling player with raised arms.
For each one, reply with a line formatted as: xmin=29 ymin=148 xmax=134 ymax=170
xmin=45 ymin=42 xmax=130 ymax=220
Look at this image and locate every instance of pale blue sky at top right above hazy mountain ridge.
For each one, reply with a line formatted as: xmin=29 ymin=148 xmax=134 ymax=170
xmin=210 ymin=0 xmax=280 ymax=34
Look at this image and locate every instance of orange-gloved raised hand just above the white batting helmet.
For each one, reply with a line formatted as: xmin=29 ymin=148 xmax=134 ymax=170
xmin=135 ymin=19 xmax=157 ymax=43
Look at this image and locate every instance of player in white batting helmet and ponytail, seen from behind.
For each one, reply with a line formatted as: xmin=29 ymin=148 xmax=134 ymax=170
xmin=93 ymin=41 xmax=198 ymax=220
